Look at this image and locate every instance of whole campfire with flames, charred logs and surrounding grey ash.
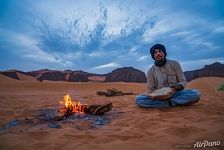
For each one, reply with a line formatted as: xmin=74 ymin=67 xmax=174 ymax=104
xmin=0 ymin=94 xmax=114 ymax=134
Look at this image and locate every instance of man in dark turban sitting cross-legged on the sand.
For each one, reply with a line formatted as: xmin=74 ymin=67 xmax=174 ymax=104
xmin=135 ymin=44 xmax=200 ymax=107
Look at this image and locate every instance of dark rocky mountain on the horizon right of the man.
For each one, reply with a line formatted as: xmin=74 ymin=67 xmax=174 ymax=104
xmin=184 ymin=62 xmax=224 ymax=81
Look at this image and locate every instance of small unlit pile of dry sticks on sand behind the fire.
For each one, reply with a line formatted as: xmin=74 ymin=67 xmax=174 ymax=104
xmin=96 ymin=88 xmax=134 ymax=97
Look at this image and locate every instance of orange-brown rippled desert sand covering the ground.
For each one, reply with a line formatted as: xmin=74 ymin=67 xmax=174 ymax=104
xmin=0 ymin=76 xmax=224 ymax=150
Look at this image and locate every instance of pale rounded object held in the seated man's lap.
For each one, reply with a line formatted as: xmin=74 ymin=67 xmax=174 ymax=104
xmin=149 ymin=87 xmax=174 ymax=100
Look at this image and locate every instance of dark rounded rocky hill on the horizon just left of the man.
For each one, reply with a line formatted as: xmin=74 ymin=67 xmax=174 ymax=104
xmin=105 ymin=67 xmax=146 ymax=83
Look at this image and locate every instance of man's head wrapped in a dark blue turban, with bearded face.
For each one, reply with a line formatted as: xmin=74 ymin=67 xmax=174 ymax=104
xmin=150 ymin=44 xmax=167 ymax=61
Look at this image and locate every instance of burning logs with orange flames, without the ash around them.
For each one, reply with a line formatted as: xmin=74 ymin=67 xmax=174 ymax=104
xmin=56 ymin=94 xmax=113 ymax=120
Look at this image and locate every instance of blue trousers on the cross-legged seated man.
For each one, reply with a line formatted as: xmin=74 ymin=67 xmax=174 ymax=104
xmin=135 ymin=89 xmax=201 ymax=108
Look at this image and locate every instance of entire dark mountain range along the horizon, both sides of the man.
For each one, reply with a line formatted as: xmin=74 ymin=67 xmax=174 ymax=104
xmin=0 ymin=62 xmax=224 ymax=83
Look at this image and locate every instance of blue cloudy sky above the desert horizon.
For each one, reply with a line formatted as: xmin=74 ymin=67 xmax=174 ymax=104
xmin=0 ymin=0 xmax=224 ymax=73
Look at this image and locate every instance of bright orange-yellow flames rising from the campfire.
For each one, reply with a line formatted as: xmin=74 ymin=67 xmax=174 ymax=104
xmin=59 ymin=94 xmax=87 ymax=114
